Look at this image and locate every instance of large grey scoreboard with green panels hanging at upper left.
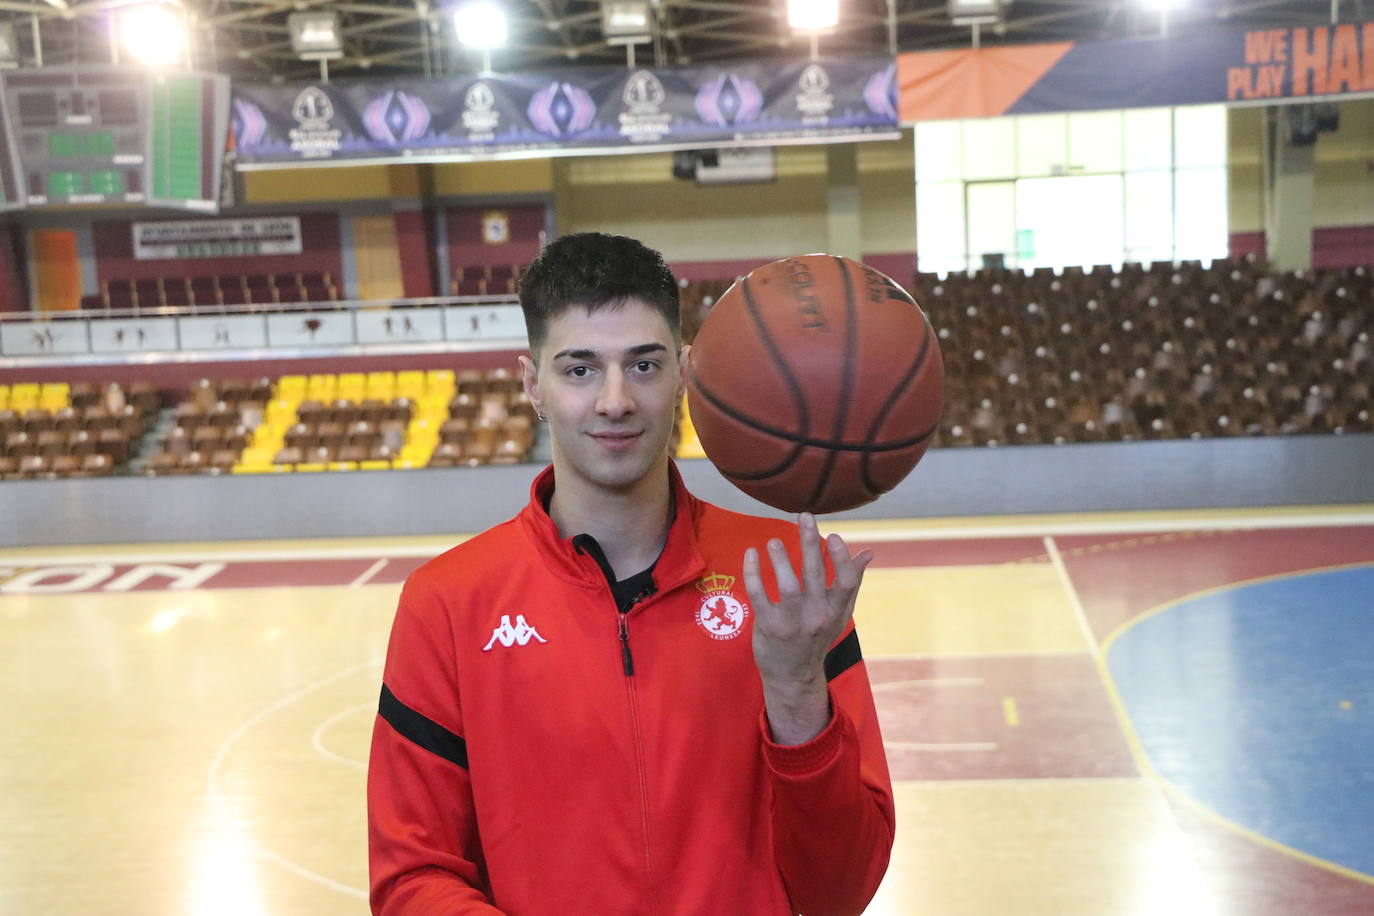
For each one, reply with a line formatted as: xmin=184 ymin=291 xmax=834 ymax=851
xmin=0 ymin=67 xmax=229 ymax=210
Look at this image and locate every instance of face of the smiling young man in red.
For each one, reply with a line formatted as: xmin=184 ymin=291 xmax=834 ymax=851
xmin=521 ymin=299 xmax=686 ymax=490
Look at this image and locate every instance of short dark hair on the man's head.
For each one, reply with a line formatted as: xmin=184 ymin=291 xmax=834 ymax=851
xmin=519 ymin=232 xmax=682 ymax=356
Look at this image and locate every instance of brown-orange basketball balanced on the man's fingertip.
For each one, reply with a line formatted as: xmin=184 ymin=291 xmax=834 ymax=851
xmin=687 ymin=254 xmax=944 ymax=514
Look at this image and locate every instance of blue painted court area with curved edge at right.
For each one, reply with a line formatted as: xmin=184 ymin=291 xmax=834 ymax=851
xmin=1106 ymin=566 xmax=1374 ymax=875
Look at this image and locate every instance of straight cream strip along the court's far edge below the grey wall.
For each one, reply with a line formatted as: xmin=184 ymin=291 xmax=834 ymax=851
xmin=10 ymin=504 xmax=1374 ymax=566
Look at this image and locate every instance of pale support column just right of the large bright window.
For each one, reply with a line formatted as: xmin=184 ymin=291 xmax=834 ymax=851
xmin=1264 ymin=106 xmax=1316 ymax=271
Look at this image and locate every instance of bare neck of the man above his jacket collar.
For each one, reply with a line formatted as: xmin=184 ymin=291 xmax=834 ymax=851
xmin=548 ymin=456 xmax=672 ymax=580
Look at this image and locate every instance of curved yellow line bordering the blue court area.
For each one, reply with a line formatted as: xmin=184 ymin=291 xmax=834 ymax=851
xmin=1102 ymin=560 xmax=1374 ymax=884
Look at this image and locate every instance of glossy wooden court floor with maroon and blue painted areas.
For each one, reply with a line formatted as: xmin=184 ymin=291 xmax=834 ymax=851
xmin=0 ymin=505 xmax=1374 ymax=916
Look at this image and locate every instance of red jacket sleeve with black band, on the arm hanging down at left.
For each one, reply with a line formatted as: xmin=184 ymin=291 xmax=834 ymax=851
xmin=367 ymin=584 xmax=500 ymax=916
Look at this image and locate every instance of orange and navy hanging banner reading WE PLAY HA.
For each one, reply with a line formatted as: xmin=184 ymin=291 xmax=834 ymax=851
xmin=897 ymin=22 xmax=1374 ymax=124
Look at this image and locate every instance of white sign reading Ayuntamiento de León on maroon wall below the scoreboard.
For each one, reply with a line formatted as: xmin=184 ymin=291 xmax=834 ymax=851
xmin=133 ymin=216 xmax=301 ymax=261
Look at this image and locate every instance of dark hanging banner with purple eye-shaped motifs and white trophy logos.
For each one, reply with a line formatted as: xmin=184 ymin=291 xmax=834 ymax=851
xmin=232 ymin=58 xmax=897 ymax=169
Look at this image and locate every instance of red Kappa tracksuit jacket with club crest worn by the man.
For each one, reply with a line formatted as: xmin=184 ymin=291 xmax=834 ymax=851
xmin=367 ymin=467 xmax=893 ymax=916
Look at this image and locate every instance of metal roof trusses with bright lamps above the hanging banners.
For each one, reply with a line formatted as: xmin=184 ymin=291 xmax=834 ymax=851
xmin=0 ymin=0 xmax=1352 ymax=82
